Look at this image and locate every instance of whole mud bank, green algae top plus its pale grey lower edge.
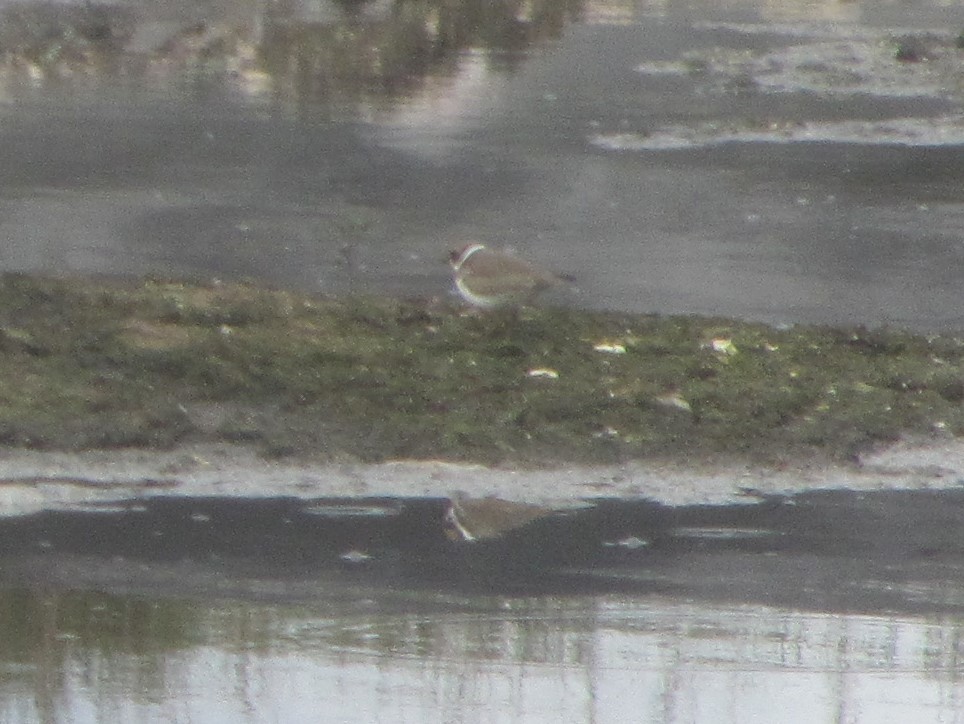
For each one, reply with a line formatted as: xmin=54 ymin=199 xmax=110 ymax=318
xmin=0 ymin=275 xmax=964 ymax=512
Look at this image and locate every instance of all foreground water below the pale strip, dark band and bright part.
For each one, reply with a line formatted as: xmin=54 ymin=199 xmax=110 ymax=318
xmin=0 ymin=490 xmax=964 ymax=722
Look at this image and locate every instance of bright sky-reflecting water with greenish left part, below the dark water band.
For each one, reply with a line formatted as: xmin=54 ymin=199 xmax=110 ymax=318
xmin=0 ymin=594 xmax=962 ymax=722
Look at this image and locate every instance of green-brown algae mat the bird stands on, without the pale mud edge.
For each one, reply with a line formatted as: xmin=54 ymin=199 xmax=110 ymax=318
xmin=0 ymin=275 xmax=964 ymax=465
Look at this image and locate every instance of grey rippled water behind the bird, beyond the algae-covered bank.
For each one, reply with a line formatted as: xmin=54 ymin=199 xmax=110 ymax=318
xmin=0 ymin=0 xmax=964 ymax=330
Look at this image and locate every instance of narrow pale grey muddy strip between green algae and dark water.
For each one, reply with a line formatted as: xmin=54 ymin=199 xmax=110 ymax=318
xmin=0 ymin=440 xmax=964 ymax=515
